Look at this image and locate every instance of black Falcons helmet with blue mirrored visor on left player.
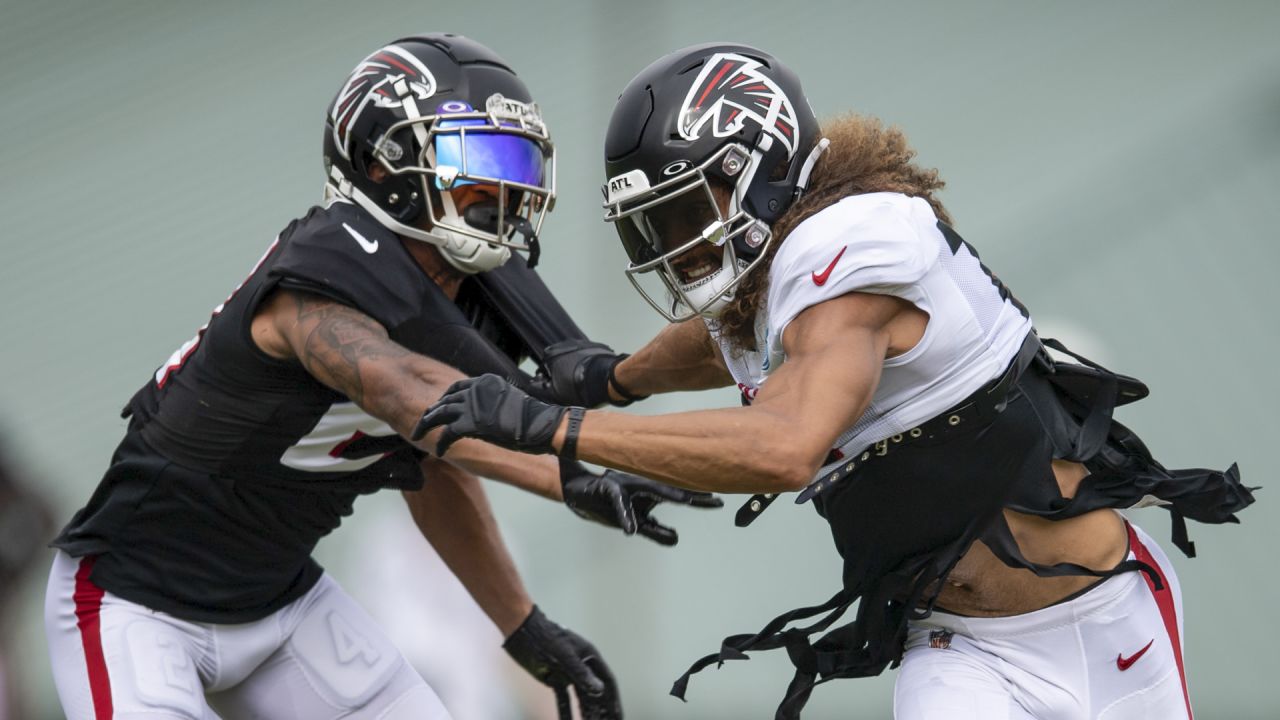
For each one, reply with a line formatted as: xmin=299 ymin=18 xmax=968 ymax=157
xmin=324 ymin=33 xmax=556 ymax=273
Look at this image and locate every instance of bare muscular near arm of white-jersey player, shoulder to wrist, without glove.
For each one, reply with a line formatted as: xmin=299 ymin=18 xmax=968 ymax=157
xmin=573 ymin=299 xmax=887 ymax=492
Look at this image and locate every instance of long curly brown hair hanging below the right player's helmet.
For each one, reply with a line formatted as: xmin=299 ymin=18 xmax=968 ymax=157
xmin=714 ymin=114 xmax=951 ymax=352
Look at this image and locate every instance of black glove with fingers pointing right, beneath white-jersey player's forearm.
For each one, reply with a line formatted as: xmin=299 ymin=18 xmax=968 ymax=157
xmin=561 ymin=459 xmax=724 ymax=546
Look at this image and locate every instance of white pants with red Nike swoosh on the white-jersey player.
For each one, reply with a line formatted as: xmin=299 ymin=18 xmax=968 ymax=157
xmin=893 ymin=525 xmax=1192 ymax=720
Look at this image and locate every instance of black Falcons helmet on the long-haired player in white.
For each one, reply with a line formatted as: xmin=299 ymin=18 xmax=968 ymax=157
xmin=603 ymin=42 xmax=827 ymax=316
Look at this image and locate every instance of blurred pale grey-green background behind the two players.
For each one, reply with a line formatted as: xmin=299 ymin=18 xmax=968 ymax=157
xmin=0 ymin=0 xmax=1280 ymax=720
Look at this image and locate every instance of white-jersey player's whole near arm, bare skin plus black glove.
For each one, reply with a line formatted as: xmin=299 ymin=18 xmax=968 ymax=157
xmin=419 ymin=292 xmax=928 ymax=492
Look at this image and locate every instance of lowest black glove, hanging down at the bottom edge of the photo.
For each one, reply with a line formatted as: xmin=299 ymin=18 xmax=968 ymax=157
xmin=502 ymin=605 xmax=622 ymax=720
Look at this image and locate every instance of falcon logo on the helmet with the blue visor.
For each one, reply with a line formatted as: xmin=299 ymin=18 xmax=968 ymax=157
xmin=329 ymin=45 xmax=435 ymax=159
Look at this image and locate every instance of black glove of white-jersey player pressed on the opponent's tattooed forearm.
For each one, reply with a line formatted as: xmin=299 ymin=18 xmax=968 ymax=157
xmin=410 ymin=374 xmax=568 ymax=456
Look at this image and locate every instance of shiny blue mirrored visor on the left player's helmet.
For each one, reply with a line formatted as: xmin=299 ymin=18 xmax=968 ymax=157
xmin=433 ymin=118 xmax=543 ymax=190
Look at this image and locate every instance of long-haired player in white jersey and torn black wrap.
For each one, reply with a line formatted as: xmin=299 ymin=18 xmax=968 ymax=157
xmin=419 ymin=44 xmax=1252 ymax=720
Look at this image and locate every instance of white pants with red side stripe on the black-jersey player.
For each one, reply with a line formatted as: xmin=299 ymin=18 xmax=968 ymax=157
xmin=45 ymin=551 xmax=449 ymax=720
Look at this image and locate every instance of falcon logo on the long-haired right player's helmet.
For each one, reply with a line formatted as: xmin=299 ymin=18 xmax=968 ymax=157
xmin=677 ymin=53 xmax=797 ymax=158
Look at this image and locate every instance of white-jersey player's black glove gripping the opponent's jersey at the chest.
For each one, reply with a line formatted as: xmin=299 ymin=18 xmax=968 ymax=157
xmin=530 ymin=340 xmax=640 ymax=407
